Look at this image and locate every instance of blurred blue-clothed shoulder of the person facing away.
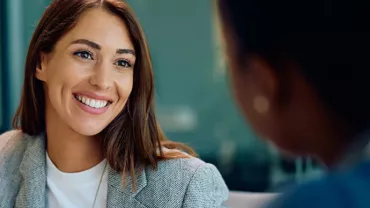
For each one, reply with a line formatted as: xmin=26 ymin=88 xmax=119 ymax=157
xmin=268 ymin=161 xmax=370 ymax=208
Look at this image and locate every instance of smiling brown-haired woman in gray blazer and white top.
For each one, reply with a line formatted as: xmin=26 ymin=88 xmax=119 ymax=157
xmin=0 ymin=0 xmax=228 ymax=208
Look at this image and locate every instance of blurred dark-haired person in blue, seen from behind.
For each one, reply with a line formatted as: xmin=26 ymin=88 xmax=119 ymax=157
xmin=218 ymin=0 xmax=370 ymax=208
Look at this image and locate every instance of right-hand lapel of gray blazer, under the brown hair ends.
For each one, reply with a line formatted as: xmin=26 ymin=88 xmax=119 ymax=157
xmin=107 ymin=167 xmax=147 ymax=208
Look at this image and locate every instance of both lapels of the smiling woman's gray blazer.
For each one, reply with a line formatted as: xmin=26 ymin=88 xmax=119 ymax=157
xmin=16 ymin=135 xmax=147 ymax=208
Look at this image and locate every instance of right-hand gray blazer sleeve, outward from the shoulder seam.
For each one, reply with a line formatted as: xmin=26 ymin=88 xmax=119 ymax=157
xmin=182 ymin=163 xmax=229 ymax=208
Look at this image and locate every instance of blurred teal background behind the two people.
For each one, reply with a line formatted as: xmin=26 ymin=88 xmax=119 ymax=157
xmin=0 ymin=0 xmax=321 ymax=192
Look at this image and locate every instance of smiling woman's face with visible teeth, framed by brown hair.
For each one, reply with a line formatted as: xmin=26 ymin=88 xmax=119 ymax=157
xmin=36 ymin=9 xmax=136 ymax=136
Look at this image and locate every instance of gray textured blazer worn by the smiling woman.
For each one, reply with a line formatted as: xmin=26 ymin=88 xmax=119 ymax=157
xmin=0 ymin=131 xmax=229 ymax=208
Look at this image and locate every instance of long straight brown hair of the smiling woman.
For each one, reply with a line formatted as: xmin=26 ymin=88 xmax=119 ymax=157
xmin=13 ymin=0 xmax=194 ymax=187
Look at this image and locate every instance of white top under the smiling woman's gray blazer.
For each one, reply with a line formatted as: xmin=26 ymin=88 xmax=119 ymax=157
xmin=46 ymin=153 xmax=108 ymax=208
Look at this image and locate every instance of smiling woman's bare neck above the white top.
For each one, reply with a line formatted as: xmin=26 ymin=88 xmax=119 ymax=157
xmin=46 ymin=107 xmax=104 ymax=173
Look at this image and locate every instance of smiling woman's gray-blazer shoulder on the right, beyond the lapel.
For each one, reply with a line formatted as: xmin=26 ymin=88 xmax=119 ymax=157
xmin=137 ymin=156 xmax=229 ymax=207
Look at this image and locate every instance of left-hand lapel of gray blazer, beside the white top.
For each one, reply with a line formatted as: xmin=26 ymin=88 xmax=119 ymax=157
xmin=15 ymin=135 xmax=46 ymax=208
